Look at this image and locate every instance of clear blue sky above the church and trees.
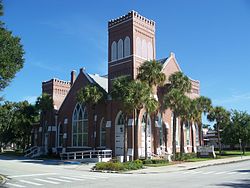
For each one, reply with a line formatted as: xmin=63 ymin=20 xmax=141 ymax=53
xmin=1 ymin=0 xmax=250 ymax=112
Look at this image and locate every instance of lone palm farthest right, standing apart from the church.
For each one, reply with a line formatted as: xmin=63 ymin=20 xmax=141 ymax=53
xmin=207 ymin=106 xmax=230 ymax=154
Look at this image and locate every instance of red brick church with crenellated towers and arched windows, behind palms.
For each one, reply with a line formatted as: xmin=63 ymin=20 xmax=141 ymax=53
xmin=33 ymin=11 xmax=202 ymax=157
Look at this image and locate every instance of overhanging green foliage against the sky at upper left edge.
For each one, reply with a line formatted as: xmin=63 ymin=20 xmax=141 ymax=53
xmin=0 ymin=1 xmax=24 ymax=91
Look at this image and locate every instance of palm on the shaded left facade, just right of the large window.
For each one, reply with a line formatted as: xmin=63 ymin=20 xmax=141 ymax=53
xmin=77 ymin=85 xmax=104 ymax=148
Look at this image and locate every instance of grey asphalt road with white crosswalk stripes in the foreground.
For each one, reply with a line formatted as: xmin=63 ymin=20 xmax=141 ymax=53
xmin=0 ymin=157 xmax=250 ymax=188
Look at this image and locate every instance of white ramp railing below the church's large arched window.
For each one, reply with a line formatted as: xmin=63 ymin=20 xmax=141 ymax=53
xmin=60 ymin=150 xmax=112 ymax=162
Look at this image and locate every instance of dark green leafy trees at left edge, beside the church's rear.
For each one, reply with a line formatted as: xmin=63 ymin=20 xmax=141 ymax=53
xmin=0 ymin=101 xmax=39 ymax=149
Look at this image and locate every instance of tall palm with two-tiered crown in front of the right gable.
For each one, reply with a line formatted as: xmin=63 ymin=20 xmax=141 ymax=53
xmin=163 ymin=72 xmax=191 ymax=160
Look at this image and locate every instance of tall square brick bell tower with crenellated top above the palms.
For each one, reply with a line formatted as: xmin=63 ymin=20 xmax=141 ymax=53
xmin=108 ymin=11 xmax=156 ymax=90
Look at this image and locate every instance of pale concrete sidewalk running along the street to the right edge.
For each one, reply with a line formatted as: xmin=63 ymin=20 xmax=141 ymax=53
xmin=129 ymin=156 xmax=250 ymax=174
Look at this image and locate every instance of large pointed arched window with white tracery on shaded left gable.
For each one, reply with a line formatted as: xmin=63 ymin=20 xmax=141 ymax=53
xmin=72 ymin=103 xmax=88 ymax=147
